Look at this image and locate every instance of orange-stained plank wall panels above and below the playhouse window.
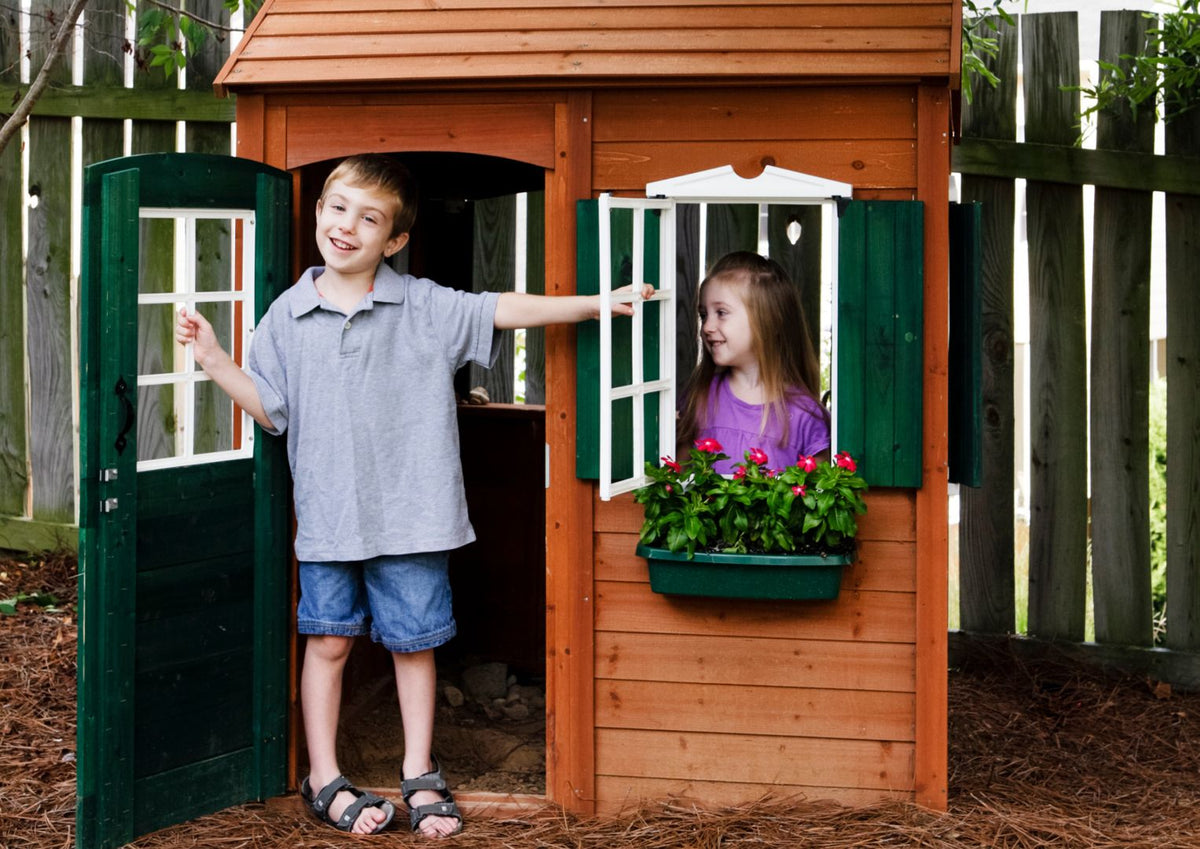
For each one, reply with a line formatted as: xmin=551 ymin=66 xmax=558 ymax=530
xmin=592 ymin=86 xmax=917 ymax=811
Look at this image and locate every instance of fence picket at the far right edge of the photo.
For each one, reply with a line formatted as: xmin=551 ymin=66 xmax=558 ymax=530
xmin=1165 ymin=109 xmax=1200 ymax=651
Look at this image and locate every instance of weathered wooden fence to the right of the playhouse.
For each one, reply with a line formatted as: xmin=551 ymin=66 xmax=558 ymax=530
xmin=952 ymin=12 xmax=1200 ymax=687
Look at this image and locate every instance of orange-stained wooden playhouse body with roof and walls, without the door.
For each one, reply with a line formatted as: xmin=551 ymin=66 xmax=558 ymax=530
xmin=216 ymin=0 xmax=960 ymax=812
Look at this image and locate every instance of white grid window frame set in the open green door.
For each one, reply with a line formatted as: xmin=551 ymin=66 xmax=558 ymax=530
xmin=137 ymin=206 xmax=256 ymax=471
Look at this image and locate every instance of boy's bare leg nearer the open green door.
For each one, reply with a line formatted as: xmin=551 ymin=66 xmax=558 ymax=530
xmin=300 ymin=634 xmax=388 ymax=835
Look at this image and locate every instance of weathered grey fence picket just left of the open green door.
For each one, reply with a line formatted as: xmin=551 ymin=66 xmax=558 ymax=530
xmin=26 ymin=0 xmax=76 ymax=524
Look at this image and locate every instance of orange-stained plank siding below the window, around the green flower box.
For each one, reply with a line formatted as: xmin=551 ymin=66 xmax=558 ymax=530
xmin=594 ymin=490 xmax=917 ymax=811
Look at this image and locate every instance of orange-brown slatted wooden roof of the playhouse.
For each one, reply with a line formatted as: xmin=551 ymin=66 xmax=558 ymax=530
xmin=215 ymin=0 xmax=960 ymax=94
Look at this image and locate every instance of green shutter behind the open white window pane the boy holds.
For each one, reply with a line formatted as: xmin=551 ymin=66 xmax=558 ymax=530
xmin=575 ymin=200 xmax=661 ymax=481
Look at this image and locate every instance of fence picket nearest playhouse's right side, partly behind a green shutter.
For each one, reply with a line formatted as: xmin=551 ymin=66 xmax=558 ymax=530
xmin=959 ymin=13 xmax=1018 ymax=633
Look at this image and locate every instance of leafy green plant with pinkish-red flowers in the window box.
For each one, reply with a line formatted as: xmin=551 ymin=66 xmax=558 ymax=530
xmin=634 ymin=439 xmax=866 ymax=558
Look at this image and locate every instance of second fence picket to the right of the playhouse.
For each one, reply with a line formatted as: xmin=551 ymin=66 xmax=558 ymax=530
xmin=1021 ymin=12 xmax=1087 ymax=642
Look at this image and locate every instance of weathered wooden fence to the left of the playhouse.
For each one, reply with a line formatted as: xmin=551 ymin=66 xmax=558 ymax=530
xmin=0 ymin=0 xmax=234 ymax=550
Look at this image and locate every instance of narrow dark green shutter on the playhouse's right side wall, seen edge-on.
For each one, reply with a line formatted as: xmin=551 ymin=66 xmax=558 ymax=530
xmin=948 ymin=203 xmax=983 ymax=487
